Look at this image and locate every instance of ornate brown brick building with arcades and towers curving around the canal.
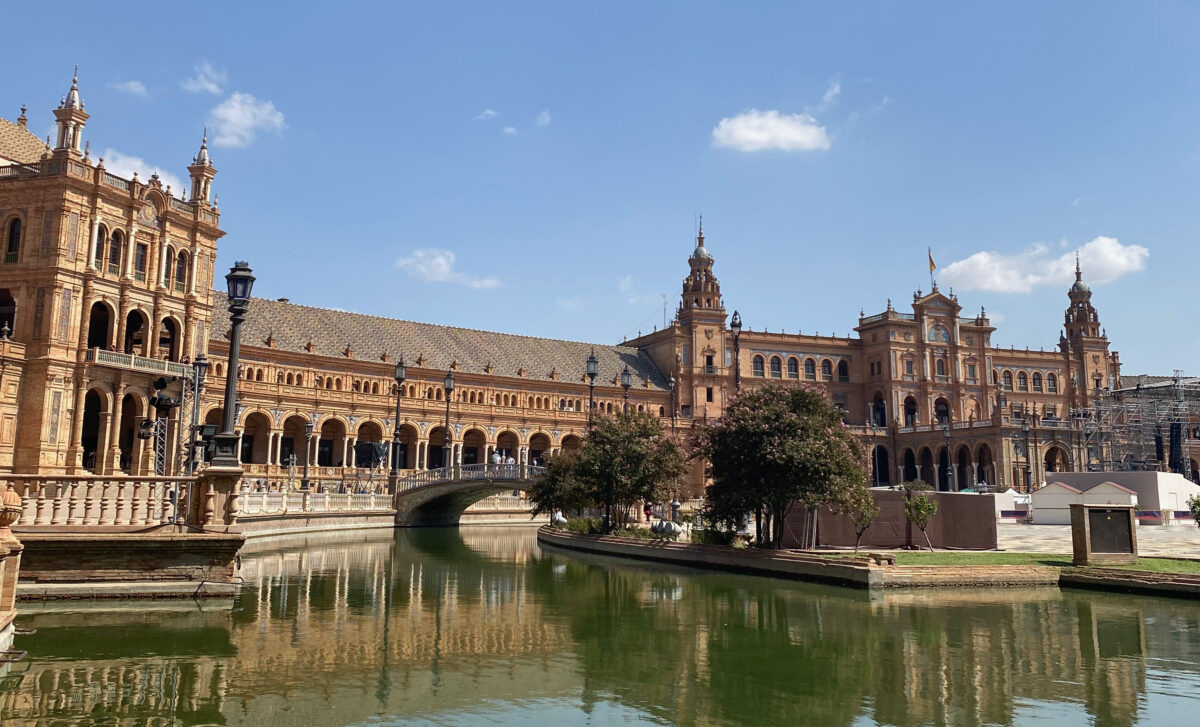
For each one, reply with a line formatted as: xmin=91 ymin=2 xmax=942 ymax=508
xmin=0 ymin=72 xmax=1120 ymax=493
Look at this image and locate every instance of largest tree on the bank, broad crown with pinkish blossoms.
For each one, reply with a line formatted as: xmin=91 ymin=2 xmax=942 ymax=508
xmin=692 ymin=384 xmax=868 ymax=548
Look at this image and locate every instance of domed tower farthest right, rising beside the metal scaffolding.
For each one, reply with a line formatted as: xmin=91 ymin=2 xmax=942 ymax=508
xmin=1058 ymin=253 xmax=1120 ymax=407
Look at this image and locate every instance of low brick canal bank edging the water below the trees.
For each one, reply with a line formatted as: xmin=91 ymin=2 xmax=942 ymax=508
xmin=538 ymin=527 xmax=1200 ymax=599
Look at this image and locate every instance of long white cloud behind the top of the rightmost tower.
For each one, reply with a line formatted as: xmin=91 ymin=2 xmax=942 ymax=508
xmin=941 ymin=235 xmax=1150 ymax=293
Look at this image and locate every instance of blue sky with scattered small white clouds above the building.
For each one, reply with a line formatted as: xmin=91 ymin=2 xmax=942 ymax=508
xmin=0 ymin=1 xmax=1200 ymax=374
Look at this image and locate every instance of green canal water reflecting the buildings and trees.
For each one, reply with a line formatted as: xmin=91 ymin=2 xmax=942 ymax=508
xmin=0 ymin=528 xmax=1200 ymax=727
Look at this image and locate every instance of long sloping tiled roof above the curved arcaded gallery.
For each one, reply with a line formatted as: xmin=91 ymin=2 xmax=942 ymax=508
xmin=212 ymin=292 xmax=668 ymax=391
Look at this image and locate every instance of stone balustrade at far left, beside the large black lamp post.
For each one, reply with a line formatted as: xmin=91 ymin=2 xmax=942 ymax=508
xmin=0 ymin=475 xmax=196 ymax=528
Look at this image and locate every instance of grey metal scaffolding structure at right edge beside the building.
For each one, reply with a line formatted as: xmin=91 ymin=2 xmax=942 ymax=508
xmin=1072 ymin=371 xmax=1200 ymax=480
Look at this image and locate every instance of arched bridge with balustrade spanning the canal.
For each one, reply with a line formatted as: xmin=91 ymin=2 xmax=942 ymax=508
xmin=395 ymin=464 xmax=546 ymax=528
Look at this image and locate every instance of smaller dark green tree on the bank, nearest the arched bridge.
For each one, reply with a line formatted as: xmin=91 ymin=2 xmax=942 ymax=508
xmin=578 ymin=410 xmax=683 ymax=528
